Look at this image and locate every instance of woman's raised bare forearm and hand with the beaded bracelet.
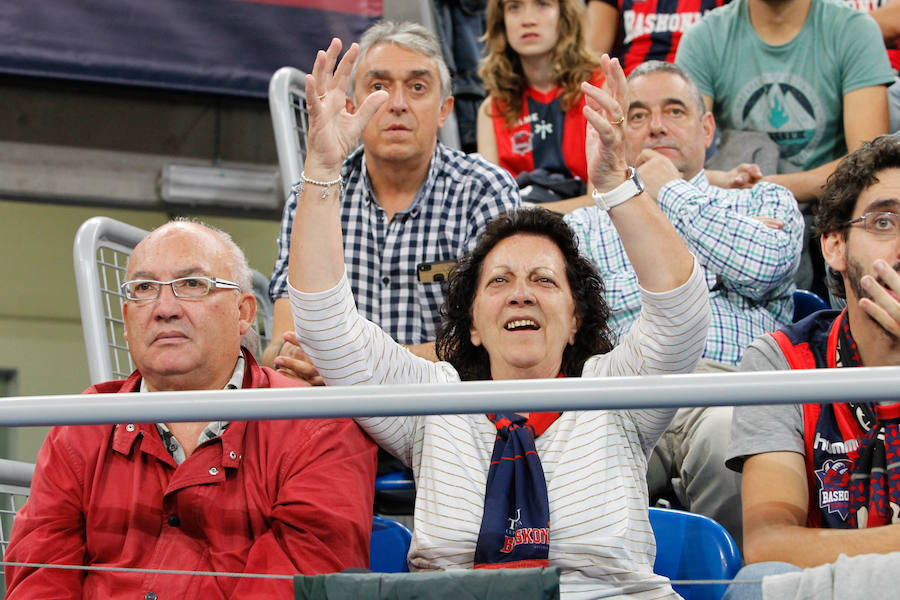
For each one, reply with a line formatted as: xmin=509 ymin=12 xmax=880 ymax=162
xmin=288 ymin=38 xmax=387 ymax=292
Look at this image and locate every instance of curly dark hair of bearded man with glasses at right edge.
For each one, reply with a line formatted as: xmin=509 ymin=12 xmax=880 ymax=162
xmin=814 ymin=135 xmax=900 ymax=298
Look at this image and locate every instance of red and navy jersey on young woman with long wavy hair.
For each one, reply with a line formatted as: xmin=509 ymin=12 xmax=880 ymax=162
xmin=492 ymin=74 xmax=603 ymax=181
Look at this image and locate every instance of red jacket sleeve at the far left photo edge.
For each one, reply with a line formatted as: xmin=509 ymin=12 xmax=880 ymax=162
xmin=5 ymin=427 xmax=86 ymax=600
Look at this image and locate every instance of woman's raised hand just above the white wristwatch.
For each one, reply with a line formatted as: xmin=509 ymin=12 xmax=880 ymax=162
xmin=581 ymin=54 xmax=628 ymax=192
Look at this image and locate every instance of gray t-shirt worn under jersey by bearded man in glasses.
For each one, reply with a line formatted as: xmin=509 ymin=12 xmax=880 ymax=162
xmin=725 ymin=334 xmax=806 ymax=473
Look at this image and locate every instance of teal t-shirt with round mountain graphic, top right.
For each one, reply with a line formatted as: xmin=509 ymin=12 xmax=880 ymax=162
xmin=675 ymin=0 xmax=894 ymax=170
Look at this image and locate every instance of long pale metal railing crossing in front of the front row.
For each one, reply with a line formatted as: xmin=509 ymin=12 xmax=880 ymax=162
xmin=0 ymin=367 xmax=900 ymax=426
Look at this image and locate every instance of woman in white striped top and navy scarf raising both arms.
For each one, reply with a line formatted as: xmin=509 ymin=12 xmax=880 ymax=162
xmin=289 ymin=40 xmax=709 ymax=599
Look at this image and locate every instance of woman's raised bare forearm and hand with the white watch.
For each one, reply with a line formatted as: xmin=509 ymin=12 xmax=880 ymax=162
xmin=582 ymin=55 xmax=694 ymax=292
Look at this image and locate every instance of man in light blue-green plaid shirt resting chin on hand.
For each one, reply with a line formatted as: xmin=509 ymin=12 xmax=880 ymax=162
xmin=566 ymin=61 xmax=803 ymax=542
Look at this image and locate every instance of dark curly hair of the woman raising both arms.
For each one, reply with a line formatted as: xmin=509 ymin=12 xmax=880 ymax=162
xmin=436 ymin=208 xmax=613 ymax=381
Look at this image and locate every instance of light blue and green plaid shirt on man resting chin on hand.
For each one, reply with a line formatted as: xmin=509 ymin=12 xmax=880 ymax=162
xmin=565 ymin=171 xmax=803 ymax=365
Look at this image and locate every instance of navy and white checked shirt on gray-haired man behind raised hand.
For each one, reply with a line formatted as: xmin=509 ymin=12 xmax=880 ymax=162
xmin=269 ymin=142 xmax=521 ymax=344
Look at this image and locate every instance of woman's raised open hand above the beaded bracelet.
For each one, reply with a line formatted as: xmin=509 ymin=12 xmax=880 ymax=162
xmin=304 ymin=38 xmax=388 ymax=176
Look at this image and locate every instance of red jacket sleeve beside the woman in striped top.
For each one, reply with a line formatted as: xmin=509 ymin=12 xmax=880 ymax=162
xmin=230 ymin=419 xmax=376 ymax=598
